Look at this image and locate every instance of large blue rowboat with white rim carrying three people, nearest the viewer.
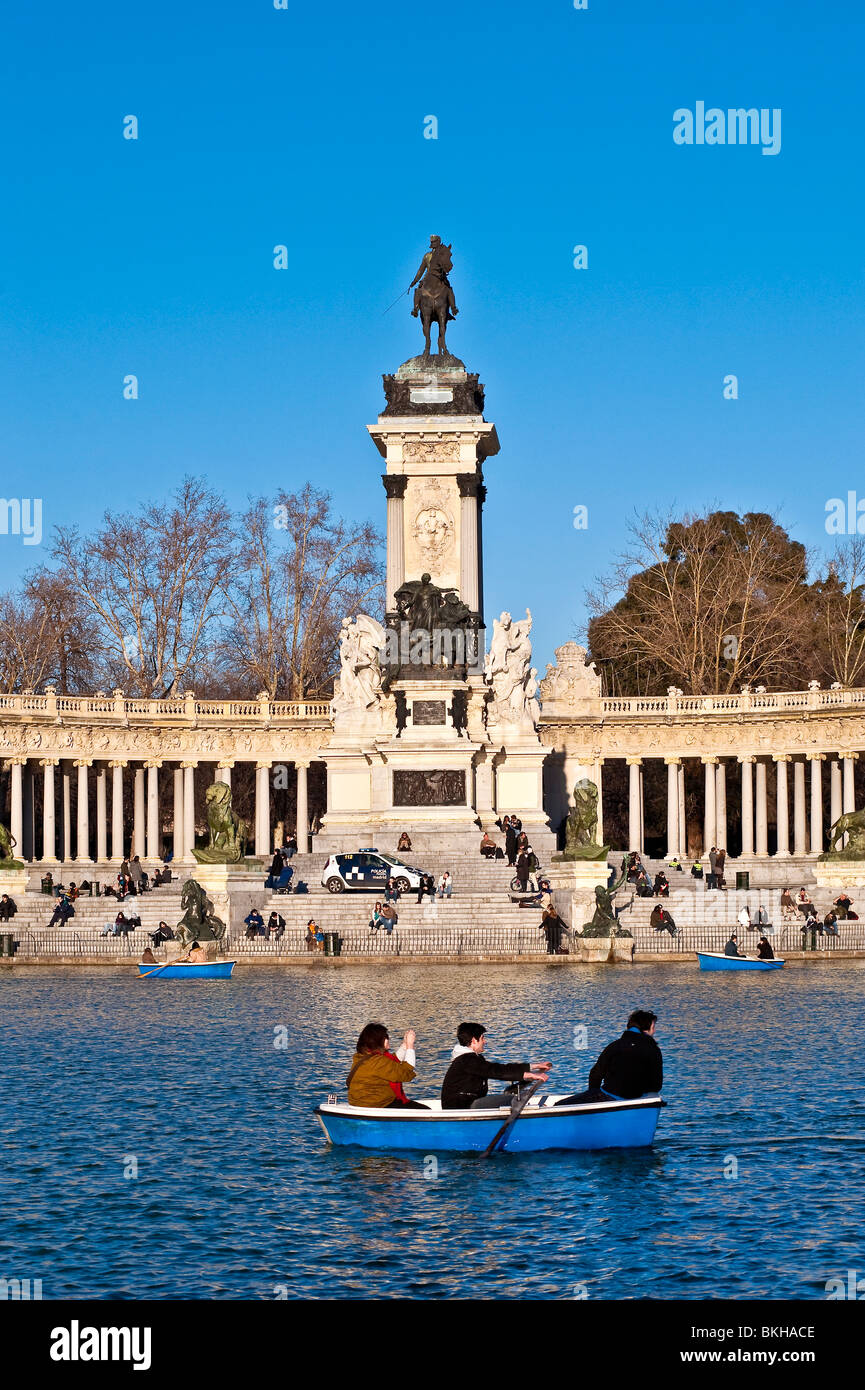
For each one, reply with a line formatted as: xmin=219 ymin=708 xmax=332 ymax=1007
xmin=316 ymin=1095 xmax=666 ymax=1154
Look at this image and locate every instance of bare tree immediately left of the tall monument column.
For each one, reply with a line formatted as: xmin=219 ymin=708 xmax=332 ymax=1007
xmin=223 ymin=484 xmax=384 ymax=699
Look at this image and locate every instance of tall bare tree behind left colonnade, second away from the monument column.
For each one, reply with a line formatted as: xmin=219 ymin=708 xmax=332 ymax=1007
xmin=54 ymin=478 xmax=234 ymax=696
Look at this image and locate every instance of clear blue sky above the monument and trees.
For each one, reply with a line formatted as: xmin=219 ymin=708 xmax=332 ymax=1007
xmin=0 ymin=0 xmax=865 ymax=670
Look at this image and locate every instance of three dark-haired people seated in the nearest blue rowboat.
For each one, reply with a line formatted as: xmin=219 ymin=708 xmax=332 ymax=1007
xmin=346 ymin=1009 xmax=663 ymax=1111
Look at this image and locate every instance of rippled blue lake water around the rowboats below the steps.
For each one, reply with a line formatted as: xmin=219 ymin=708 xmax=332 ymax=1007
xmin=0 ymin=962 xmax=865 ymax=1298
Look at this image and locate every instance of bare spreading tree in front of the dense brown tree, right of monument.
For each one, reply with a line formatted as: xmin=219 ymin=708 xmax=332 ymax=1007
xmin=587 ymin=512 xmax=814 ymax=694
